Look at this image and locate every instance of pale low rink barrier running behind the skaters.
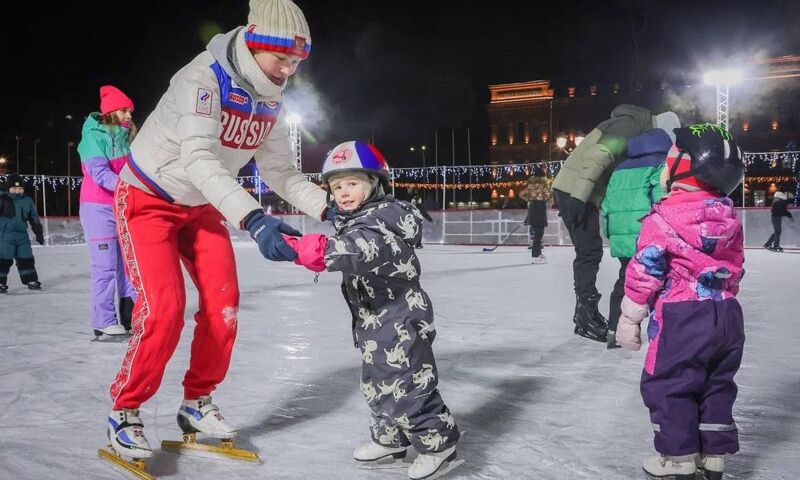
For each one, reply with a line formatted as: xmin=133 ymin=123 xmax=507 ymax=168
xmin=31 ymin=207 xmax=800 ymax=248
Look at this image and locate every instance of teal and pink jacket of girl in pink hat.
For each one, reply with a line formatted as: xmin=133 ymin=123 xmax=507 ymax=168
xmin=78 ymin=112 xmax=130 ymax=206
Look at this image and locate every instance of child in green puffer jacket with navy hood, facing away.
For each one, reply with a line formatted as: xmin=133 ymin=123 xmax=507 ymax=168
xmin=601 ymin=128 xmax=672 ymax=348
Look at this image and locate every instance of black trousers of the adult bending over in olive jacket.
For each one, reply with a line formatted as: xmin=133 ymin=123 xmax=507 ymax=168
xmin=553 ymin=190 xmax=603 ymax=297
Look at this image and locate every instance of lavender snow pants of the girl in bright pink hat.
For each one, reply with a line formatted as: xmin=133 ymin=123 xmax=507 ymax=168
xmin=80 ymin=202 xmax=136 ymax=328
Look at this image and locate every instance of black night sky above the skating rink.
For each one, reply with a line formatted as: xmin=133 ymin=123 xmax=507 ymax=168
xmin=0 ymin=0 xmax=800 ymax=174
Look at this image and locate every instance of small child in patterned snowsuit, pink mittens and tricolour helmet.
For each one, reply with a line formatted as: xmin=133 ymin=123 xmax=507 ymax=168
xmin=288 ymin=141 xmax=460 ymax=479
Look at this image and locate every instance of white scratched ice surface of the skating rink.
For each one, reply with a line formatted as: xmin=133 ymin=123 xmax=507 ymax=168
xmin=0 ymin=243 xmax=800 ymax=480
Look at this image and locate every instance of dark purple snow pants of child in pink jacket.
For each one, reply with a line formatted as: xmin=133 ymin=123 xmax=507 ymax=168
xmin=641 ymin=298 xmax=744 ymax=455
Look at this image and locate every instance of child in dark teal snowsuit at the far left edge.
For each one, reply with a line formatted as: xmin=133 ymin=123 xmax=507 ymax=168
xmin=0 ymin=174 xmax=44 ymax=293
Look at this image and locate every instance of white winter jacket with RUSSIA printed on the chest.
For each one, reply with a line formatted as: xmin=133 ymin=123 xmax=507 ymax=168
xmin=120 ymin=28 xmax=327 ymax=228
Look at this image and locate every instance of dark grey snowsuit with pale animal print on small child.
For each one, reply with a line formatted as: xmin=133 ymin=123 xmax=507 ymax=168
xmin=325 ymin=195 xmax=460 ymax=453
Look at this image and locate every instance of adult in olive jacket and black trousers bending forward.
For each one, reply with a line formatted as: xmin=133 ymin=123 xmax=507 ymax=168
xmin=553 ymin=105 xmax=680 ymax=343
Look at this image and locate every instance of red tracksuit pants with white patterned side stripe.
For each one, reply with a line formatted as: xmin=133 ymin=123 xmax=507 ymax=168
xmin=111 ymin=182 xmax=239 ymax=409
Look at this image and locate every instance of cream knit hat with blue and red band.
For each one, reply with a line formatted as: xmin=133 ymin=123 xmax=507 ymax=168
xmin=244 ymin=0 xmax=311 ymax=59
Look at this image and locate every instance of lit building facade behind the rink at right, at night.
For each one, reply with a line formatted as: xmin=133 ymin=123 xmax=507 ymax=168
xmin=487 ymin=56 xmax=800 ymax=206
